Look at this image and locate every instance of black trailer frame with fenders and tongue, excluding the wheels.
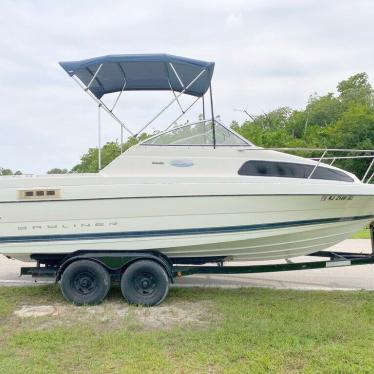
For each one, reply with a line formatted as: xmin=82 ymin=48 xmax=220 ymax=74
xmin=20 ymin=222 xmax=374 ymax=305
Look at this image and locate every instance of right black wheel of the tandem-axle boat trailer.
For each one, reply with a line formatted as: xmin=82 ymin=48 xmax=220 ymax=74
xmin=121 ymin=260 xmax=169 ymax=306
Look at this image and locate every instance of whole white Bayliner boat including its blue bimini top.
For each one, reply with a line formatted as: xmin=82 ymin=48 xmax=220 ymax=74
xmin=0 ymin=54 xmax=374 ymax=264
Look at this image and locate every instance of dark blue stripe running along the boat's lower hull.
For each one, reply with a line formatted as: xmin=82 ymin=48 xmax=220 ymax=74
xmin=0 ymin=215 xmax=374 ymax=244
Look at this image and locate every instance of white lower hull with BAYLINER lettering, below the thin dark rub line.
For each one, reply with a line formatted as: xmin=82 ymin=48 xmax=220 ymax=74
xmin=0 ymin=195 xmax=374 ymax=260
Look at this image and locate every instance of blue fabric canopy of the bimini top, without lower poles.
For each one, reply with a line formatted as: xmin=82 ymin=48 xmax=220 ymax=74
xmin=60 ymin=54 xmax=214 ymax=99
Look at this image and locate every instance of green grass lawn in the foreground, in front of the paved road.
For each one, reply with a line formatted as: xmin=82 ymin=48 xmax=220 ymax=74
xmin=0 ymin=285 xmax=374 ymax=374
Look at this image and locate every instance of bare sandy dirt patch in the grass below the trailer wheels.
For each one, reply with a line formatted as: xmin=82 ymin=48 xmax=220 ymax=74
xmin=13 ymin=301 xmax=217 ymax=329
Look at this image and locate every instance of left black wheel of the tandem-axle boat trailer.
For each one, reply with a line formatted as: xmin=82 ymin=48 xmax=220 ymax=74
xmin=60 ymin=260 xmax=111 ymax=305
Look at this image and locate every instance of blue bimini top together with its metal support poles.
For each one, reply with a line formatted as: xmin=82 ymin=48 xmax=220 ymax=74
xmin=60 ymin=54 xmax=215 ymax=169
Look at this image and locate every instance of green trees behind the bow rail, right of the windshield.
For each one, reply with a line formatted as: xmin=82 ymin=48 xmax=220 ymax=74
xmin=232 ymin=73 xmax=374 ymax=177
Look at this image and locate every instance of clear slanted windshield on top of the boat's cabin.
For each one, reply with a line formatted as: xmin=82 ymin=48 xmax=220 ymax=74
xmin=142 ymin=121 xmax=251 ymax=147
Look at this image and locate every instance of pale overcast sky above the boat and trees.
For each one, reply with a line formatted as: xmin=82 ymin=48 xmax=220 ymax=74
xmin=0 ymin=0 xmax=374 ymax=174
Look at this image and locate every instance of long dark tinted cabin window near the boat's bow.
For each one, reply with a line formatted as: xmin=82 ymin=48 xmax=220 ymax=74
xmin=238 ymin=160 xmax=353 ymax=182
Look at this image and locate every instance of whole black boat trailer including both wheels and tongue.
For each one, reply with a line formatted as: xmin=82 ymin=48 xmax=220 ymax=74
xmin=20 ymin=222 xmax=374 ymax=306
